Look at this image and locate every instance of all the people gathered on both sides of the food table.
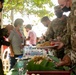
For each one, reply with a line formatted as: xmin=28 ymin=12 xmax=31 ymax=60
xmin=0 ymin=0 xmax=76 ymax=75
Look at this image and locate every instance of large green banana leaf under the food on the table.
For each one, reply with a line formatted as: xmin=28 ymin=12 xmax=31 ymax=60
xmin=27 ymin=59 xmax=64 ymax=71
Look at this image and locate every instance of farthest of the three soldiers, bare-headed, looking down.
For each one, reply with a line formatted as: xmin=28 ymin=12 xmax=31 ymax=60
xmin=41 ymin=16 xmax=51 ymax=41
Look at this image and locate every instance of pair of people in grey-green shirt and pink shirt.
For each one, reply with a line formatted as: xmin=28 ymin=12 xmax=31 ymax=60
xmin=8 ymin=18 xmax=36 ymax=68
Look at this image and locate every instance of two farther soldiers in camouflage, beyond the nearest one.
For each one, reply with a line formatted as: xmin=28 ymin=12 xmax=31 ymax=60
xmin=41 ymin=6 xmax=68 ymax=59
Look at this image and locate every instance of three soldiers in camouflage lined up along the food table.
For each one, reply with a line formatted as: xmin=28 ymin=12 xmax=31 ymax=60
xmin=41 ymin=0 xmax=76 ymax=70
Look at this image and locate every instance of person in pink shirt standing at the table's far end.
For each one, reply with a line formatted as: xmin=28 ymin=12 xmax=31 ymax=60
xmin=25 ymin=24 xmax=37 ymax=46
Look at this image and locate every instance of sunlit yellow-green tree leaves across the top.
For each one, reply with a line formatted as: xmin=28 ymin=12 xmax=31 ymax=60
xmin=4 ymin=0 xmax=53 ymax=17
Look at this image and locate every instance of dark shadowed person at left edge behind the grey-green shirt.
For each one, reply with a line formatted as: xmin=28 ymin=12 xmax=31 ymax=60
xmin=0 ymin=28 xmax=10 ymax=75
